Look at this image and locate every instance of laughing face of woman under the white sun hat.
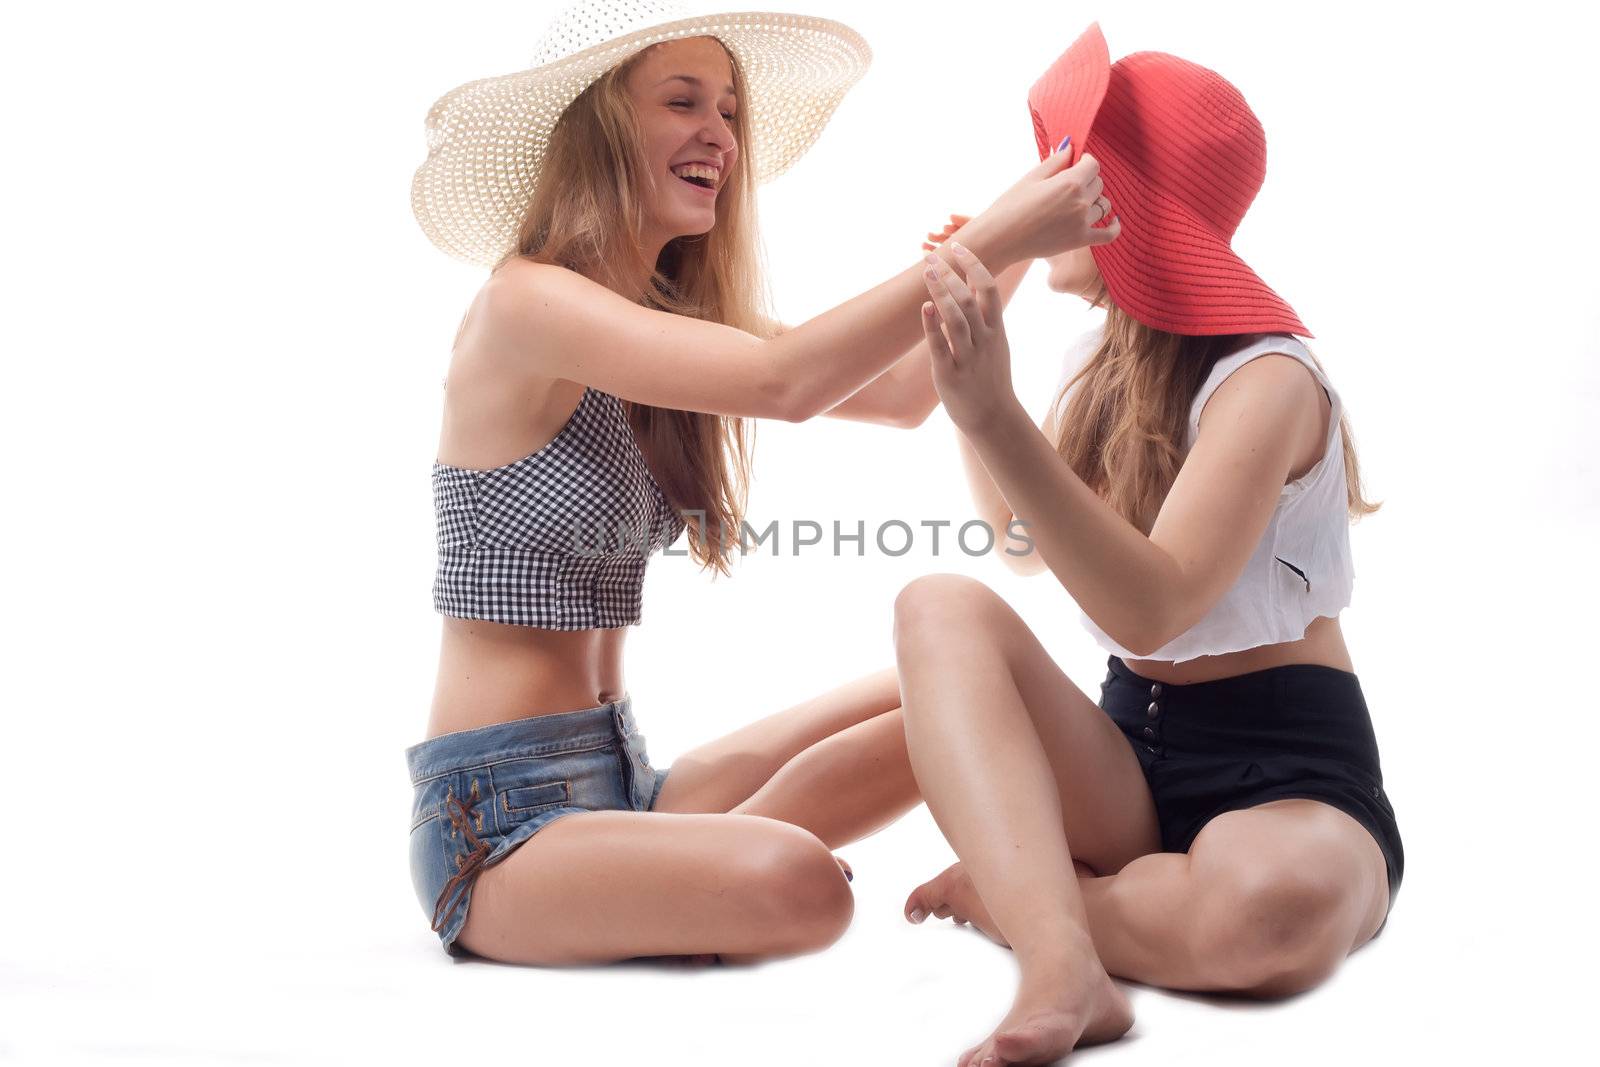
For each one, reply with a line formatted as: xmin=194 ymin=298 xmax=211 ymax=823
xmin=627 ymin=37 xmax=739 ymax=245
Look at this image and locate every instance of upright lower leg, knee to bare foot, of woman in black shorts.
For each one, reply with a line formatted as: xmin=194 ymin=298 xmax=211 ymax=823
xmin=894 ymin=577 xmax=1144 ymax=1065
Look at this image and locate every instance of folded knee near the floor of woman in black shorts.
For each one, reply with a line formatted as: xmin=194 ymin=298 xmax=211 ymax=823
xmin=1195 ymin=867 xmax=1349 ymax=998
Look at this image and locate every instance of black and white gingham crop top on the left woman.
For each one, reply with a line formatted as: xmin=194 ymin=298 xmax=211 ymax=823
xmin=434 ymin=389 xmax=683 ymax=630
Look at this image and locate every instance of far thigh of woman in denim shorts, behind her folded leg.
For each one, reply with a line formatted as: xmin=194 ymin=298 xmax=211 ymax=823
xmin=653 ymin=667 xmax=899 ymax=814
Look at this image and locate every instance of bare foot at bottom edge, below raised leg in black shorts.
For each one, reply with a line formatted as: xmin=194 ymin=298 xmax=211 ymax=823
xmin=958 ymin=936 xmax=1133 ymax=1067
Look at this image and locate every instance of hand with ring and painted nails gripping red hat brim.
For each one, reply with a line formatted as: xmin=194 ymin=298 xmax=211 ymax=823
xmin=971 ymin=138 xmax=1122 ymax=264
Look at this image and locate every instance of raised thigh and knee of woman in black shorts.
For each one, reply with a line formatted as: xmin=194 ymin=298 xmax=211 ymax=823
xmin=896 ymin=574 xmax=1162 ymax=875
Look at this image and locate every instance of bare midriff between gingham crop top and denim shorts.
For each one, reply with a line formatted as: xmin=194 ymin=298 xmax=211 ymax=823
xmin=427 ymin=616 xmax=627 ymax=737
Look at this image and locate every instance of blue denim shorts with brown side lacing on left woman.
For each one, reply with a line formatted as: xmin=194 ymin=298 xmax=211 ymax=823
xmin=405 ymin=696 xmax=667 ymax=955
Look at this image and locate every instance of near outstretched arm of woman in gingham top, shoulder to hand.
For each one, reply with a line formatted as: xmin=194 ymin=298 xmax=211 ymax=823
xmin=480 ymin=152 xmax=1114 ymax=422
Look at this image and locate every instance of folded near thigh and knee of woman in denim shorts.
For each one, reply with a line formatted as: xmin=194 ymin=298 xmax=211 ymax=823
xmin=459 ymin=811 xmax=853 ymax=965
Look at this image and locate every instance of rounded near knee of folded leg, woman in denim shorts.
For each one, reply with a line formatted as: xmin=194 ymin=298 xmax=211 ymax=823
xmin=742 ymin=824 xmax=856 ymax=955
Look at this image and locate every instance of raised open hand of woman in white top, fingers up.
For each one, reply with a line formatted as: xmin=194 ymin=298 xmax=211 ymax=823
xmin=922 ymin=242 xmax=1021 ymax=434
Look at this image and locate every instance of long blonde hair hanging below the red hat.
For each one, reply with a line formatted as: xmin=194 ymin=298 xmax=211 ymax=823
xmin=1053 ymin=282 xmax=1381 ymax=536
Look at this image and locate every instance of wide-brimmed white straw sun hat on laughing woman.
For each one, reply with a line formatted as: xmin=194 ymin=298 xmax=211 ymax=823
xmin=411 ymin=0 xmax=872 ymax=267
